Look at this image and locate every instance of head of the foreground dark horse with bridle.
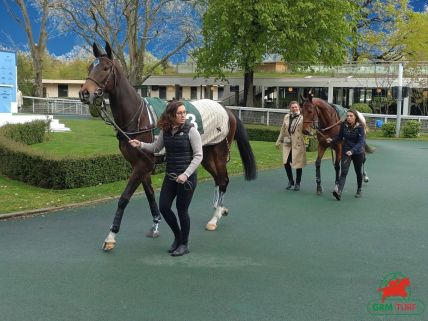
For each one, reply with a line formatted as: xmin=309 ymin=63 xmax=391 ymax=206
xmin=79 ymin=42 xmax=117 ymax=104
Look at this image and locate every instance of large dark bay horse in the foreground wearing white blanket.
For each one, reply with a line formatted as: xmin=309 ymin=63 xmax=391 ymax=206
xmin=79 ymin=43 xmax=257 ymax=250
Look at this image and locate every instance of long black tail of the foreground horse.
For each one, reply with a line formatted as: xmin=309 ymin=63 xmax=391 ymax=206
xmin=235 ymin=117 xmax=257 ymax=181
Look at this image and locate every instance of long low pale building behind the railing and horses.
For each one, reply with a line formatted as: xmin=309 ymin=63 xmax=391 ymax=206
xmin=43 ymin=73 xmax=428 ymax=115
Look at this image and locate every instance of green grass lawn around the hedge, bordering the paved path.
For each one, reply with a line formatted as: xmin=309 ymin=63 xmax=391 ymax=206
xmin=0 ymin=119 xmax=315 ymax=214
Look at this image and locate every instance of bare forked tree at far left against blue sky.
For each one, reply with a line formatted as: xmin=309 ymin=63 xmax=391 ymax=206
xmin=3 ymin=0 xmax=49 ymax=97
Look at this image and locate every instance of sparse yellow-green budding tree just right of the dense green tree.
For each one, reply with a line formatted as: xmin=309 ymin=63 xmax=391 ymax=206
xmin=349 ymin=0 xmax=414 ymax=62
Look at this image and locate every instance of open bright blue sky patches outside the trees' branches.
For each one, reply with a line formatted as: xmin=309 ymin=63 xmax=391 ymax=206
xmin=0 ymin=0 xmax=428 ymax=56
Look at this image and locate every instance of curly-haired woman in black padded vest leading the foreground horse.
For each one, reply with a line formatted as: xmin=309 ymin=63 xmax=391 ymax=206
xmin=129 ymin=101 xmax=203 ymax=256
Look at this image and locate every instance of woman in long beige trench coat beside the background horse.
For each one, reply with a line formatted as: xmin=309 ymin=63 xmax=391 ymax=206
xmin=276 ymin=101 xmax=306 ymax=191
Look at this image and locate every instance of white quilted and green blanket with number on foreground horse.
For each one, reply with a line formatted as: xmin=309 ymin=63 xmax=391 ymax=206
xmin=145 ymin=97 xmax=229 ymax=146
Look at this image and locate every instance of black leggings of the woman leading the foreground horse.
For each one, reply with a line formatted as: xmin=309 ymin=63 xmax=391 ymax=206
xmin=159 ymin=174 xmax=197 ymax=245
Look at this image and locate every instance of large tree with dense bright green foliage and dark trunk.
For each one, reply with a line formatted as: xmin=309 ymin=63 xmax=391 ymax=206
xmin=195 ymin=0 xmax=352 ymax=106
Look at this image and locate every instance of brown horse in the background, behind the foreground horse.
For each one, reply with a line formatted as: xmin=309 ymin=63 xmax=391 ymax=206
xmin=302 ymin=93 xmax=372 ymax=195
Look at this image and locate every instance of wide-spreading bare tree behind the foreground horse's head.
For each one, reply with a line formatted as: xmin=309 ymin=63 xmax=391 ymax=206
xmin=51 ymin=0 xmax=202 ymax=85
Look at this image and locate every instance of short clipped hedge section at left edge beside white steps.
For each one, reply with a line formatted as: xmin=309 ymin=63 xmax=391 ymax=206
xmin=1 ymin=120 xmax=50 ymax=145
